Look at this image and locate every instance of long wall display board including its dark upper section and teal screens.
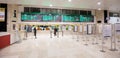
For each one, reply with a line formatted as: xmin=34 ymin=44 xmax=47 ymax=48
xmin=21 ymin=7 xmax=94 ymax=22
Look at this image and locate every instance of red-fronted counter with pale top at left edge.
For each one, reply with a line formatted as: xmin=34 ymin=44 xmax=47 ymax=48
xmin=0 ymin=32 xmax=10 ymax=49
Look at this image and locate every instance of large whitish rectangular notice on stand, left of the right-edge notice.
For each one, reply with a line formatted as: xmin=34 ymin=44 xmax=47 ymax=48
xmin=102 ymin=25 xmax=112 ymax=37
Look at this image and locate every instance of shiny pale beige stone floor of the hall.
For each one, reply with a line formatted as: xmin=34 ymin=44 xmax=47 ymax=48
xmin=0 ymin=32 xmax=120 ymax=58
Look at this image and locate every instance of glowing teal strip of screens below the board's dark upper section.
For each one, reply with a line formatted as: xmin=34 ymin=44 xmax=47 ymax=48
xmin=21 ymin=13 xmax=94 ymax=22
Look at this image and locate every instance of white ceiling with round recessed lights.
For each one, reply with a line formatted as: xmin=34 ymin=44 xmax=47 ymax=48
xmin=0 ymin=0 xmax=120 ymax=11
